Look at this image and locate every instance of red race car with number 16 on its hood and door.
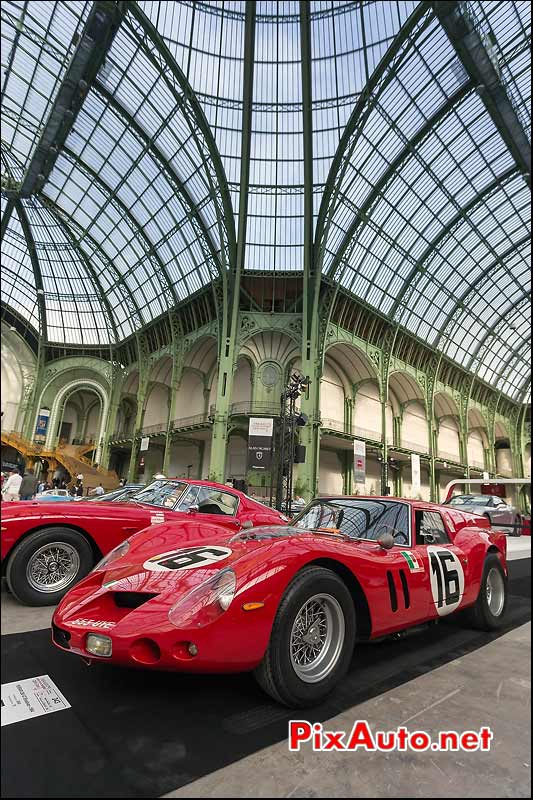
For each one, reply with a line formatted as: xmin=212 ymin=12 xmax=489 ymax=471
xmin=52 ymin=497 xmax=507 ymax=707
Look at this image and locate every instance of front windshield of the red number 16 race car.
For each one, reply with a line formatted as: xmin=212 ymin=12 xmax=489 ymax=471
xmin=291 ymin=499 xmax=409 ymax=545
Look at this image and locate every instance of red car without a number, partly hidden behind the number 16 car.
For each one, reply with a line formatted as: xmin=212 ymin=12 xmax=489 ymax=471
xmin=1 ymin=480 xmax=287 ymax=605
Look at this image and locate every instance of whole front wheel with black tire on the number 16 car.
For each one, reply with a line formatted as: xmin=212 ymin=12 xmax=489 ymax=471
xmin=254 ymin=567 xmax=356 ymax=708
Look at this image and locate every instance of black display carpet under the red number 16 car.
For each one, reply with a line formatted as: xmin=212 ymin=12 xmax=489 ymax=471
xmin=2 ymin=559 xmax=531 ymax=798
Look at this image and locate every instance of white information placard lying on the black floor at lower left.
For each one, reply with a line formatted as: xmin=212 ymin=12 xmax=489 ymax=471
xmin=2 ymin=675 xmax=70 ymax=726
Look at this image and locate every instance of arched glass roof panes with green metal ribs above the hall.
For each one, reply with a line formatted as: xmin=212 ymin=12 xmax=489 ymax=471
xmin=2 ymin=0 xmax=531 ymax=399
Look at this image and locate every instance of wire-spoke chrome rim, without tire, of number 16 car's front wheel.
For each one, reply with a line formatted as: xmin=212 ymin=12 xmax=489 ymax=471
xmin=290 ymin=594 xmax=345 ymax=683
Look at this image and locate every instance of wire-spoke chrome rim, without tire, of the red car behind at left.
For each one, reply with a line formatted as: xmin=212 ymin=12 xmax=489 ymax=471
xmin=26 ymin=542 xmax=80 ymax=594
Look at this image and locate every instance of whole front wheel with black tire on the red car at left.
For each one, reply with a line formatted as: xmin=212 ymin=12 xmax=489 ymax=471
xmin=6 ymin=527 xmax=94 ymax=606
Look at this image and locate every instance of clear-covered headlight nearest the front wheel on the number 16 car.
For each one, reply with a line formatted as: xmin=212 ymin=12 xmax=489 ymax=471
xmin=168 ymin=567 xmax=237 ymax=628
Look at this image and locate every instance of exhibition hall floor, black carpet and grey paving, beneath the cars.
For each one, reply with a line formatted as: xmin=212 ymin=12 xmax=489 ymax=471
xmin=2 ymin=552 xmax=531 ymax=797
